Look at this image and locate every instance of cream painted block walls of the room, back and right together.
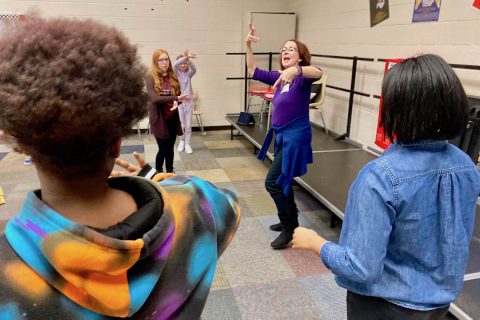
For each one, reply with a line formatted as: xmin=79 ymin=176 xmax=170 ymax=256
xmin=0 ymin=0 xmax=480 ymax=145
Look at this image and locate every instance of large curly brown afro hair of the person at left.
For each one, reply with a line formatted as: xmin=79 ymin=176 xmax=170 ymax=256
xmin=0 ymin=17 xmax=147 ymax=174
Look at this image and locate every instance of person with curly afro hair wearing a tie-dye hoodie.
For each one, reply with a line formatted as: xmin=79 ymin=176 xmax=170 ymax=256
xmin=0 ymin=16 xmax=240 ymax=319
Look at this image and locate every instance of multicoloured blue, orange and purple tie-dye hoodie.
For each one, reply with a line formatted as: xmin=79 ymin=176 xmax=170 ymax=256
xmin=0 ymin=176 xmax=240 ymax=320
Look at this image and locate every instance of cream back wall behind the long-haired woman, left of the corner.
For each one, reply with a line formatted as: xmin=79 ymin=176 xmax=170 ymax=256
xmin=0 ymin=0 xmax=287 ymax=127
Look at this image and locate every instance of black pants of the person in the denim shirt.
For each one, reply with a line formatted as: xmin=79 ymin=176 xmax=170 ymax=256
xmin=347 ymin=291 xmax=449 ymax=320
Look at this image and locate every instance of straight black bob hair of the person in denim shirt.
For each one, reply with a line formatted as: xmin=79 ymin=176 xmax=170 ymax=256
xmin=380 ymin=54 xmax=469 ymax=144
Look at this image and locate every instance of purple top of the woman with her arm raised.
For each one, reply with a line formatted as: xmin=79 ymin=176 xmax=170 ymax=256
xmin=253 ymin=68 xmax=316 ymax=126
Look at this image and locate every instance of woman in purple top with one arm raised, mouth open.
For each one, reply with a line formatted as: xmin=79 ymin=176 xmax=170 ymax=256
xmin=245 ymin=25 xmax=322 ymax=249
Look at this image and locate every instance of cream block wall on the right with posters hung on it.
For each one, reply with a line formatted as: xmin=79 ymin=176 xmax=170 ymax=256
xmin=287 ymin=0 xmax=480 ymax=149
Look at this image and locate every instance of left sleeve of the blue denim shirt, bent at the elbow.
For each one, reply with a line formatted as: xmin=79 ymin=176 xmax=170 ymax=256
xmin=320 ymin=161 xmax=395 ymax=283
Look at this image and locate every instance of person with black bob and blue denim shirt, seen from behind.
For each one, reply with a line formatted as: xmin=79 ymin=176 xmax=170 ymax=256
xmin=292 ymin=55 xmax=480 ymax=320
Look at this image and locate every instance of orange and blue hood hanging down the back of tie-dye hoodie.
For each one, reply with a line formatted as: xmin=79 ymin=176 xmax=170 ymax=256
xmin=5 ymin=178 xmax=175 ymax=317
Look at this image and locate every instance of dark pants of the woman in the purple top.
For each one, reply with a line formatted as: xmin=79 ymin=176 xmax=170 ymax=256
xmin=265 ymin=148 xmax=298 ymax=231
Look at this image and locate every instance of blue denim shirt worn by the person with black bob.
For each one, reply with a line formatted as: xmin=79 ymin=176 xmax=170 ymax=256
xmin=320 ymin=141 xmax=480 ymax=310
